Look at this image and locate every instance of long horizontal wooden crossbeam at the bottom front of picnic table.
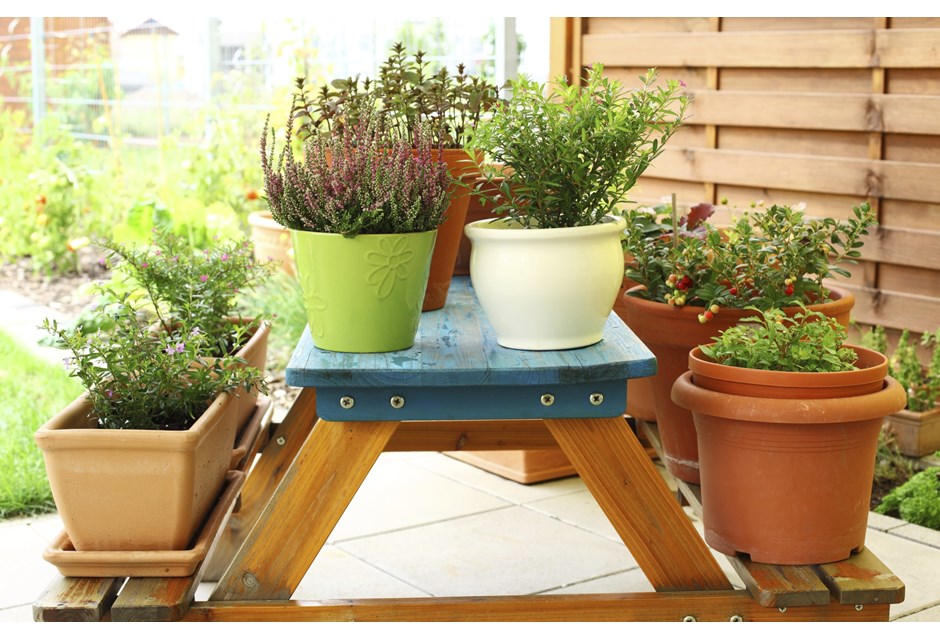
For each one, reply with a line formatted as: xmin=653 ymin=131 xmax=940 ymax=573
xmin=184 ymin=590 xmax=888 ymax=622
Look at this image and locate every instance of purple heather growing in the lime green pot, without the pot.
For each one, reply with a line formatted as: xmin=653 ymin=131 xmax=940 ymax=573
xmin=261 ymin=99 xmax=451 ymax=237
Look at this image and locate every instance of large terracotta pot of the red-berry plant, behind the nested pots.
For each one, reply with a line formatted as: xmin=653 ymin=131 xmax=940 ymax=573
xmin=622 ymin=287 xmax=855 ymax=484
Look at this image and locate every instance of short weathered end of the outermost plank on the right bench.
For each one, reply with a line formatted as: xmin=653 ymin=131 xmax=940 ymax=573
xmin=814 ymin=549 xmax=905 ymax=606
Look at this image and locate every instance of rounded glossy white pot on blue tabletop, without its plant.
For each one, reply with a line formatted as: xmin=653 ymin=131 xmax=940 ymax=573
xmin=464 ymin=216 xmax=626 ymax=351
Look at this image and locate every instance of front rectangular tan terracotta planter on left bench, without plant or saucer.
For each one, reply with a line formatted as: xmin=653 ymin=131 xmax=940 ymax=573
xmin=35 ymin=394 xmax=236 ymax=551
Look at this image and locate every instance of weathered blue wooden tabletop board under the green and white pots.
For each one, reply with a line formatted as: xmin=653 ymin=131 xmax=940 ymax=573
xmin=286 ymin=276 xmax=656 ymax=389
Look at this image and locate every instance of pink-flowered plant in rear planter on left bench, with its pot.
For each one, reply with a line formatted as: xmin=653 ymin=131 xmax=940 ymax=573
xmin=102 ymin=228 xmax=275 ymax=427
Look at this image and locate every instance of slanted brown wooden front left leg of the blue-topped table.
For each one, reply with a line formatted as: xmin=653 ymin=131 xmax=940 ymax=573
xmin=209 ymin=420 xmax=399 ymax=600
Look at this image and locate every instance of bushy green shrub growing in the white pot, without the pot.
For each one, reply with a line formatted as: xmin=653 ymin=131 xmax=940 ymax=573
xmin=469 ymin=64 xmax=689 ymax=229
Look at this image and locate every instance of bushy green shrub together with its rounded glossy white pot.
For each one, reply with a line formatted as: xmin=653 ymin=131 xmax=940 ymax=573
xmin=465 ymin=64 xmax=688 ymax=350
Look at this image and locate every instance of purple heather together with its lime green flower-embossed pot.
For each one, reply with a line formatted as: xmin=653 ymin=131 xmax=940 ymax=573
xmin=261 ymin=94 xmax=450 ymax=353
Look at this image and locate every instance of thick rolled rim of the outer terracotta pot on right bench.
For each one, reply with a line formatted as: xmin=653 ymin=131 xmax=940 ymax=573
xmin=671 ymin=371 xmax=907 ymax=424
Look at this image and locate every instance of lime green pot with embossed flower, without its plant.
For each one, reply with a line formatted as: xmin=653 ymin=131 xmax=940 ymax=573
xmin=291 ymin=229 xmax=437 ymax=353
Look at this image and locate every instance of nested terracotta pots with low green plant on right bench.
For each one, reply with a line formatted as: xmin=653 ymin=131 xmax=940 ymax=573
xmin=672 ymin=307 xmax=905 ymax=564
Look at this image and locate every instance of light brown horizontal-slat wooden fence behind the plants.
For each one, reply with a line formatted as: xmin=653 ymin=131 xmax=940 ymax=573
xmin=556 ymin=17 xmax=940 ymax=335
